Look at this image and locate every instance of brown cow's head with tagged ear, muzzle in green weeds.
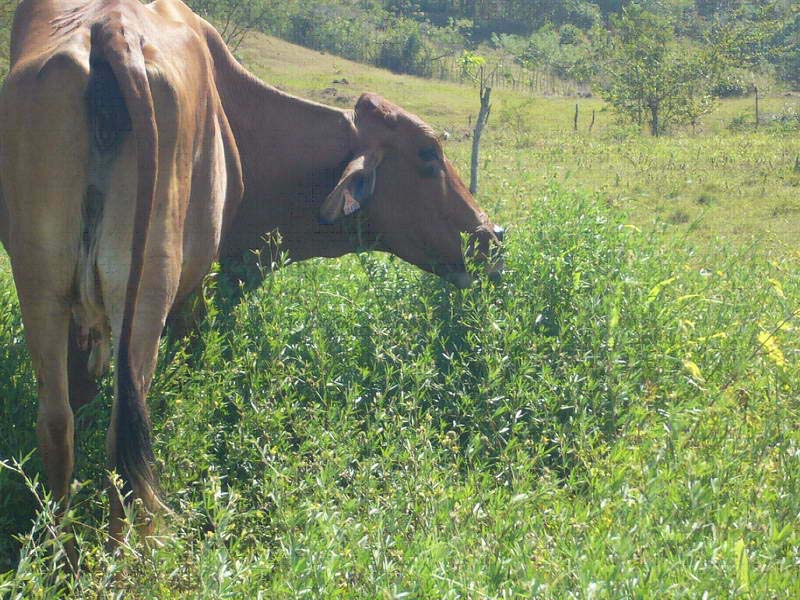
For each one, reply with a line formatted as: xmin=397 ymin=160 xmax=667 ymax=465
xmin=320 ymin=94 xmax=503 ymax=287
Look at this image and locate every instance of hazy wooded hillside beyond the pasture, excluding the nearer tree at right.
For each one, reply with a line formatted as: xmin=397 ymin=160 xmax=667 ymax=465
xmin=183 ymin=0 xmax=800 ymax=95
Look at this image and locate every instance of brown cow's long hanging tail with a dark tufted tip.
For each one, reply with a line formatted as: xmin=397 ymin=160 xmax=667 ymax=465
xmin=90 ymin=20 xmax=158 ymax=504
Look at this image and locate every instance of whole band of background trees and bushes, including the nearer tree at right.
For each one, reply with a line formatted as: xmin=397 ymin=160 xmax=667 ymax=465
xmin=0 ymin=0 xmax=800 ymax=135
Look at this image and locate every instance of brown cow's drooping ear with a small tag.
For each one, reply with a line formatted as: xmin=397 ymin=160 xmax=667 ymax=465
xmin=320 ymin=150 xmax=383 ymax=225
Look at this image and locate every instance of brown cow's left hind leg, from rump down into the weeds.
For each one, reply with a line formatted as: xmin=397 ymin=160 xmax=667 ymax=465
xmin=0 ymin=55 xmax=88 ymax=567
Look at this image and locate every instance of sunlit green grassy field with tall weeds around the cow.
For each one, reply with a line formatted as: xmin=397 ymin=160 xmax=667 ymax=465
xmin=0 ymin=31 xmax=800 ymax=599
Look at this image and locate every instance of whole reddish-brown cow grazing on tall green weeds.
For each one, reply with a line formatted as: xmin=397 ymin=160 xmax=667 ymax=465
xmin=0 ymin=0 xmax=502 ymax=560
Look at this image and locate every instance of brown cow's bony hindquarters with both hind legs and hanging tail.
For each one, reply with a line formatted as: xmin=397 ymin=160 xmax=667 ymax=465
xmin=0 ymin=1 xmax=242 ymax=552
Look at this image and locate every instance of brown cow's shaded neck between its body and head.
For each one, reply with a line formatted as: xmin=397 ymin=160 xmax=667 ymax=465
xmin=212 ymin=41 xmax=362 ymax=260
